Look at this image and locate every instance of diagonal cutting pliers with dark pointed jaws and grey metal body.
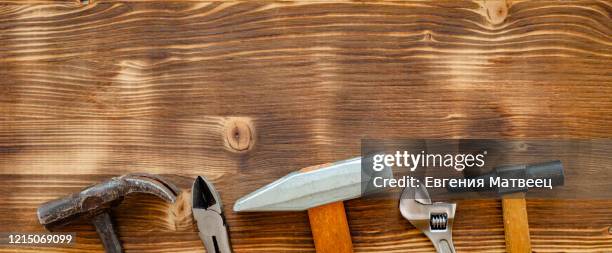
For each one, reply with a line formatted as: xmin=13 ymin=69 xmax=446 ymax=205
xmin=191 ymin=176 xmax=232 ymax=253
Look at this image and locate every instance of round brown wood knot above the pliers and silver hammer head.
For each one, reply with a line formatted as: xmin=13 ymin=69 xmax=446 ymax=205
xmin=225 ymin=117 xmax=254 ymax=152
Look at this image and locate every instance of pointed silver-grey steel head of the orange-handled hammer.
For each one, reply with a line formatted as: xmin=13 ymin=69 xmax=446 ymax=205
xmin=234 ymin=157 xmax=393 ymax=212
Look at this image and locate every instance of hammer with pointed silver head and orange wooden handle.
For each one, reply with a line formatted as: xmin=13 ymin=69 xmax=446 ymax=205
xmin=234 ymin=157 xmax=393 ymax=253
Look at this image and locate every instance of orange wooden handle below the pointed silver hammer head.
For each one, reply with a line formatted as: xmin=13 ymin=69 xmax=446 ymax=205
xmin=308 ymin=202 xmax=353 ymax=253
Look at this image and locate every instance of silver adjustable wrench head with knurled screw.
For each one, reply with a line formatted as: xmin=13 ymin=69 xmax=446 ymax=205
xmin=399 ymin=184 xmax=457 ymax=253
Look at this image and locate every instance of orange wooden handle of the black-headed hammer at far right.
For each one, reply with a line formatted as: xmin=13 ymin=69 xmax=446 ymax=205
xmin=502 ymin=192 xmax=531 ymax=253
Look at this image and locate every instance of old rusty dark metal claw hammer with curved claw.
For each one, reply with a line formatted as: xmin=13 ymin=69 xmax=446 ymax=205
xmin=38 ymin=173 xmax=180 ymax=253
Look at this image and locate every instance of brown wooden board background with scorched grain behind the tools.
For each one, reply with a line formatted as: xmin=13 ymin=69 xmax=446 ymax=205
xmin=0 ymin=0 xmax=612 ymax=252
